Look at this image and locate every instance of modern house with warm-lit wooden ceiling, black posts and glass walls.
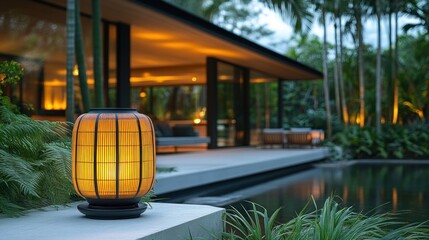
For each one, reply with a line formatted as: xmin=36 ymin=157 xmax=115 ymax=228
xmin=0 ymin=0 xmax=322 ymax=148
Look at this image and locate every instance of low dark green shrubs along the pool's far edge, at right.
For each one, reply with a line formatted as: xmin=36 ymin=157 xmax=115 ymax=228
xmin=332 ymin=125 xmax=429 ymax=159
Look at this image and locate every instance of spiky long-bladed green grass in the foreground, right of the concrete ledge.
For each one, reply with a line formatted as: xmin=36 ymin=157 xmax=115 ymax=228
xmin=223 ymin=197 xmax=429 ymax=240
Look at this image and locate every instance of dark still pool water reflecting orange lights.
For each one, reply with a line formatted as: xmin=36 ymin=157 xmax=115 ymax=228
xmin=228 ymin=164 xmax=429 ymax=222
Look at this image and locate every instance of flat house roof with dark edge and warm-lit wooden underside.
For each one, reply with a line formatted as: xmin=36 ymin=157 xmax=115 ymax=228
xmin=42 ymin=0 xmax=323 ymax=82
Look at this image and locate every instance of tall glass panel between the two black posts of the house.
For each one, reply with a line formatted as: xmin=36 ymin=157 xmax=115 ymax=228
xmin=217 ymin=62 xmax=245 ymax=147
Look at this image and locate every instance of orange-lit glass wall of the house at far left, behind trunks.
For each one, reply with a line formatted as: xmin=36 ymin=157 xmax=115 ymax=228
xmin=0 ymin=0 xmax=97 ymax=120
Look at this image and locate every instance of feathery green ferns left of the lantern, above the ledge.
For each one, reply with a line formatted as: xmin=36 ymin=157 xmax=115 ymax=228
xmin=0 ymin=106 xmax=74 ymax=216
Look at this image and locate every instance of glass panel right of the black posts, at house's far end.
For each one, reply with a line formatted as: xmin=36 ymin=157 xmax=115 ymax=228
xmin=249 ymin=71 xmax=279 ymax=145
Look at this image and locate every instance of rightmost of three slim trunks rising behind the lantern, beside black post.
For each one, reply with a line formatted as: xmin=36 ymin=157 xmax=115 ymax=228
xmin=92 ymin=0 xmax=104 ymax=107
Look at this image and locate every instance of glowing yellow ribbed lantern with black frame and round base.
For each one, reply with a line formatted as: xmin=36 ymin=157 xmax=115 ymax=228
xmin=72 ymin=109 xmax=155 ymax=219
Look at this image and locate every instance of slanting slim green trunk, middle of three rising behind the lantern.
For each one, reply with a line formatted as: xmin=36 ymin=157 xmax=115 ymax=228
xmin=75 ymin=0 xmax=91 ymax=112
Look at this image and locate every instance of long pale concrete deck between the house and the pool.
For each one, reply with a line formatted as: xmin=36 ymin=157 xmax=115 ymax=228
xmin=154 ymin=147 xmax=328 ymax=195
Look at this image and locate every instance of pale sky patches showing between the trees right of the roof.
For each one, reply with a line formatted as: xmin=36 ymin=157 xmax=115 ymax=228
xmin=251 ymin=3 xmax=417 ymax=54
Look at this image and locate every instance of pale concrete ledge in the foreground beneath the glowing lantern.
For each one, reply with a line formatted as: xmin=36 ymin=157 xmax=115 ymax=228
xmin=0 ymin=203 xmax=224 ymax=240
